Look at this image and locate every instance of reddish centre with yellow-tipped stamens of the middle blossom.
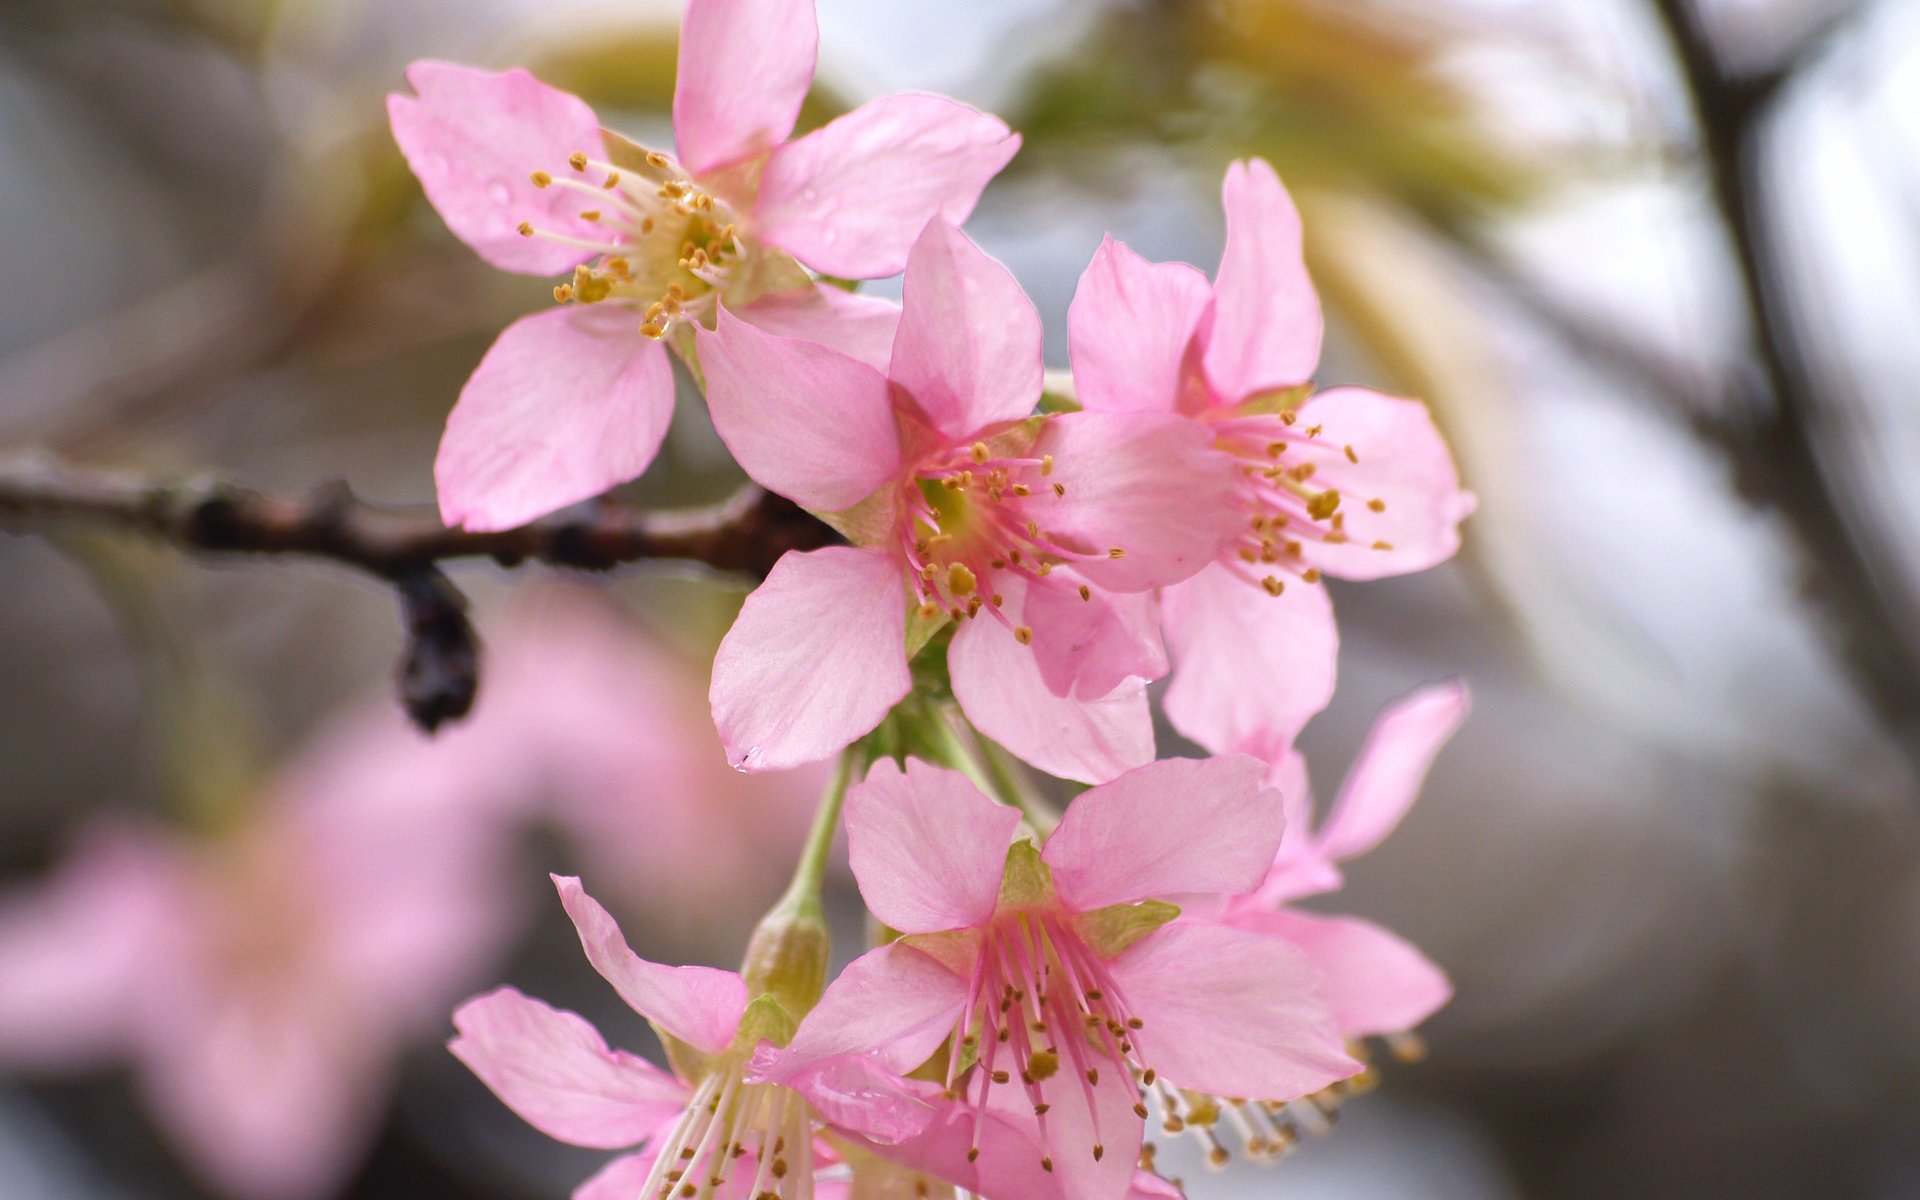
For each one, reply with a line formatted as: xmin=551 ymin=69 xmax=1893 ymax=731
xmin=899 ymin=442 xmax=1125 ymax=643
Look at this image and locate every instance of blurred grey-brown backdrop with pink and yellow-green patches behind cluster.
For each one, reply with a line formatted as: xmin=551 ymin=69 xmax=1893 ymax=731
xmin=0 ymin=0 xmax=1920 ymax=1200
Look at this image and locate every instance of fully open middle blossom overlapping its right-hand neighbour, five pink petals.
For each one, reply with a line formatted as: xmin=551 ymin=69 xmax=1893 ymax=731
xmin=701 ymin=221 xmax=1240 ymax=781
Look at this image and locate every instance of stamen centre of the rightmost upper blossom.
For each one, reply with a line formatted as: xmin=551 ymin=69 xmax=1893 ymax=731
xmin=1213 ymin=411 xmax=1394 ymax=595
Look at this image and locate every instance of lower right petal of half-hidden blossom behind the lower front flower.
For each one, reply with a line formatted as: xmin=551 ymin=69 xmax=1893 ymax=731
xmin=1233 ymin=908 xmax=1453 ymax=1037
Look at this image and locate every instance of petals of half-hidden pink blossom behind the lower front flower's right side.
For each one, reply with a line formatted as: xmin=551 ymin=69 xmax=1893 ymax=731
xmin=1221 ymin=684 xmax=1469 ymax=1037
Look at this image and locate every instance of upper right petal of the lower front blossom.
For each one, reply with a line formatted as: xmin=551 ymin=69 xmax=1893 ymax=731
xmin=1041 ymin=755 xmax=1281 ymax=912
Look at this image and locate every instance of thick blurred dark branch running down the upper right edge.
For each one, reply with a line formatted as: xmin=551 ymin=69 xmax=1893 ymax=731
xmin=1655 ymin=0 xmax=1920 ymax=762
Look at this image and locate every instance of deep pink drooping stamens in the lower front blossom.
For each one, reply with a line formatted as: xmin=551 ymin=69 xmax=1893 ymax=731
xmin=947 ymin=910 xmax=1156 ymax=1171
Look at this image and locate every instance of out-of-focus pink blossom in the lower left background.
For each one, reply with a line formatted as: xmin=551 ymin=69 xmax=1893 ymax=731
xmin=0 ymin=714 xmax=516 ymax=1200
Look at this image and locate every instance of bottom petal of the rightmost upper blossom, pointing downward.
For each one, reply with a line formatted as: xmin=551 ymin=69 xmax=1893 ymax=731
xmin=1160 ymin=564 xmax=1340 ymax=762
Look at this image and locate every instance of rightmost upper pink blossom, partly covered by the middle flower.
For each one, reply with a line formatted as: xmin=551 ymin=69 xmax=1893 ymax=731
xmin=1068 ymin=159 xmax=1475 ymax=758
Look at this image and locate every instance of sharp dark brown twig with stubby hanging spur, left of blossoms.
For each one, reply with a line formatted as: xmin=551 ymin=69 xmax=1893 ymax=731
xmin=0 ymin=459 xmax=837 ymax=732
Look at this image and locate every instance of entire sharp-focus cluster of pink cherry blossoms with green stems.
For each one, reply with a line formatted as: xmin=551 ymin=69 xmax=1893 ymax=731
xmin=390 ymin=0 xmax=1473 ymax=1200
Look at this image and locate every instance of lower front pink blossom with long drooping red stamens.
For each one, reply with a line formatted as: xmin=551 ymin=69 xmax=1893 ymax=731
xmin=768 ymin=756 xmax=1359 ymax=1200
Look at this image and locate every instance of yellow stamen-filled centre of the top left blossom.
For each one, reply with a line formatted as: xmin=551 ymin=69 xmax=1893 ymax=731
xmin=520 ymin=148 xmax=747 ymax=338
